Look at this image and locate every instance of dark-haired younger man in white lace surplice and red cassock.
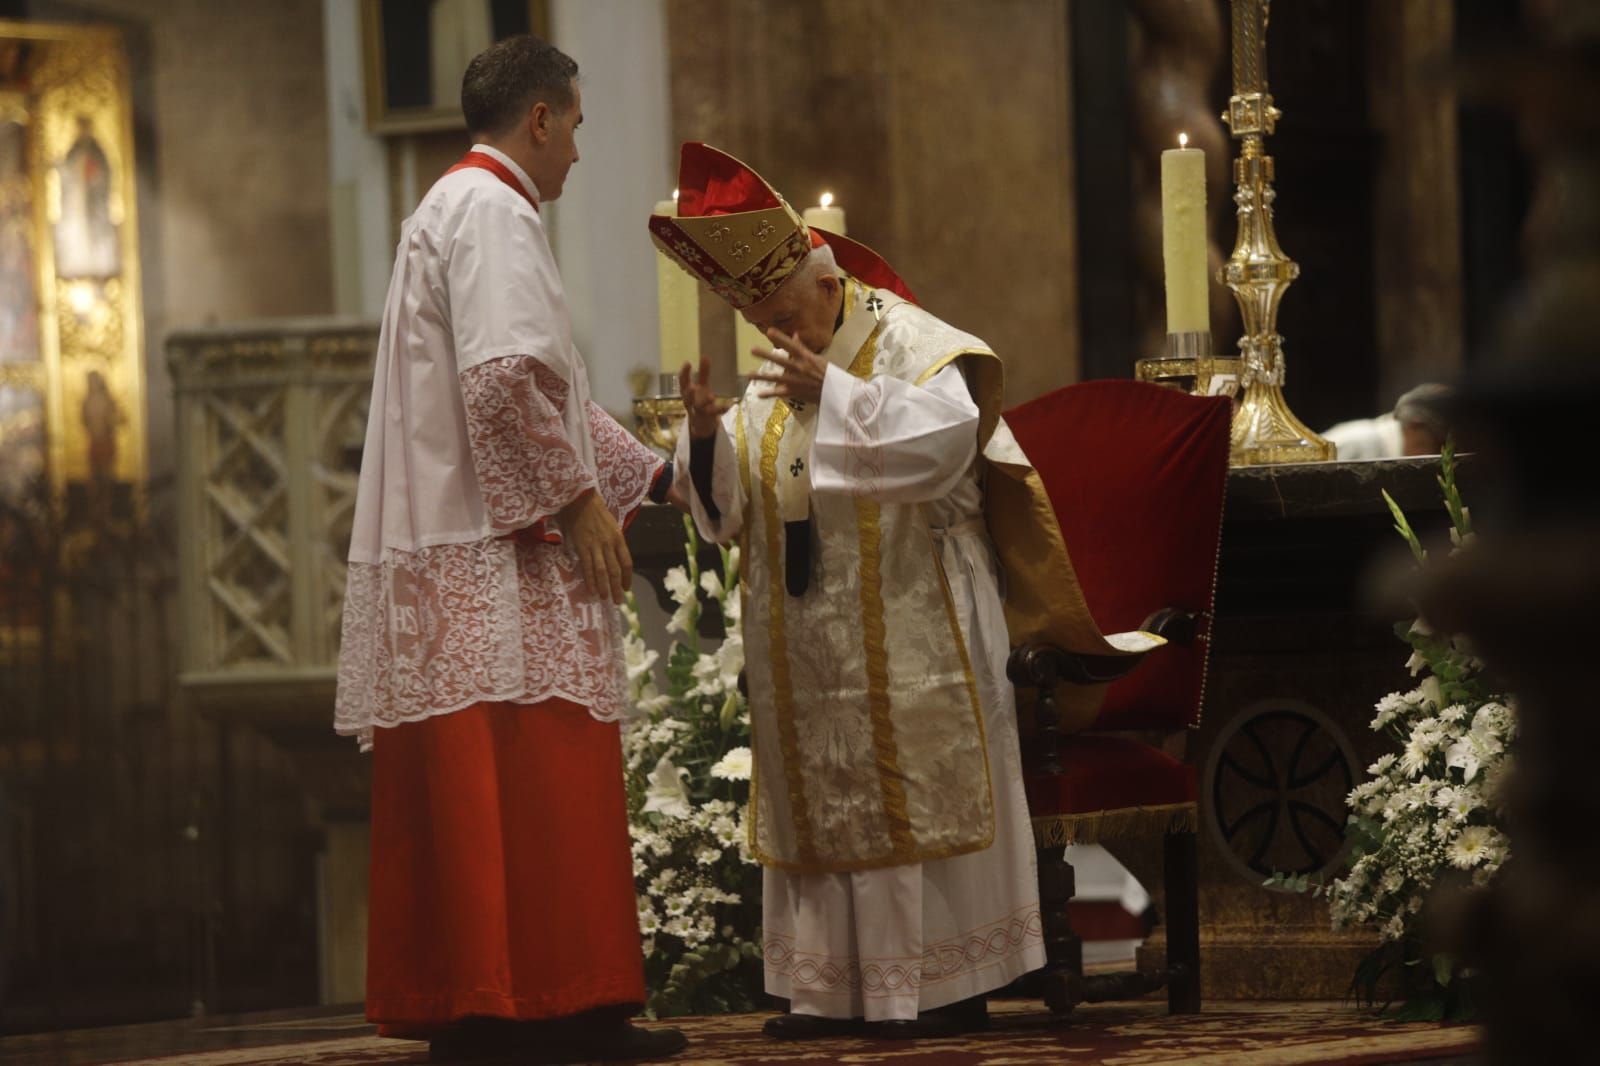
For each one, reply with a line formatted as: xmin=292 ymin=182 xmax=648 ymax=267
xmin=334 ymin=37 xmax=683 ymax=1061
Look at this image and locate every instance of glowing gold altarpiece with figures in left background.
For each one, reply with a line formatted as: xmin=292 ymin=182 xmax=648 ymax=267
xmin=0 ymin=21 xmax=147 ymax=520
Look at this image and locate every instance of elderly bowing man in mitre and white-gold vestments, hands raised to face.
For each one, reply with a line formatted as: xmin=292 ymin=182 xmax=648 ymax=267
xmin=651 ymin=144 xmax=1059 ymax=1039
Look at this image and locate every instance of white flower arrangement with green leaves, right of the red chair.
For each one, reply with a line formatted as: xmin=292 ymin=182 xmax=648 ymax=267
xmin=1266 ymin=443 xmax=1517 ymax=1020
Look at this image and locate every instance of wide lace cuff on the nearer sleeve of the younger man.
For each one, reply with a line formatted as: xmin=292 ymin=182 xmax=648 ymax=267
xmin=461 ymin=355 xmax=598 ymax=535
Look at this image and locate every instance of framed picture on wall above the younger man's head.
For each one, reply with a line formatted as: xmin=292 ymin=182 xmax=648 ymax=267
xmin=362 ymin=0 xmax=550 ymax=133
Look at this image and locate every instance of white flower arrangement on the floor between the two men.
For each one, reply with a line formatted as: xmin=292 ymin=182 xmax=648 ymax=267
xmin=622 ymin=519 xmax=762 ymax=1018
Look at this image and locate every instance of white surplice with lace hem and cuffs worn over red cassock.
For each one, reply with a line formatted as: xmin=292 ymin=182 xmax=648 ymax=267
xmin=334 ymin=144 xmax=661 ymax=747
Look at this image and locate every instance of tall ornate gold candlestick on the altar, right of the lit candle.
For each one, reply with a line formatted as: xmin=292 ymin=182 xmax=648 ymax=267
xmin=1218 ymin=0 xmax=1334 ymax=466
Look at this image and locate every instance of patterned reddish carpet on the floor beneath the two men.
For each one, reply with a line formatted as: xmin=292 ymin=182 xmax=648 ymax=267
xmin=0 ymin=999 xmax=1478 ymax=1066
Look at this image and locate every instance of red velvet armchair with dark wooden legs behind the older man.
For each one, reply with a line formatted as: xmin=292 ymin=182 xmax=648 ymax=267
xmin=1006 ymin=381 xmax=1232 ymax=1015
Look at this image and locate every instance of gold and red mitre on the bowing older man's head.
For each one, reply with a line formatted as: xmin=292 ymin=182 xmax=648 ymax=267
xmin=650 ymin=141 xmax=915 ymax=309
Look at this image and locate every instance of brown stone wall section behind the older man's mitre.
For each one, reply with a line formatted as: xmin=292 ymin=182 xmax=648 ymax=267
xmin=667 ymin=0 xmax=1078 ymax=403
